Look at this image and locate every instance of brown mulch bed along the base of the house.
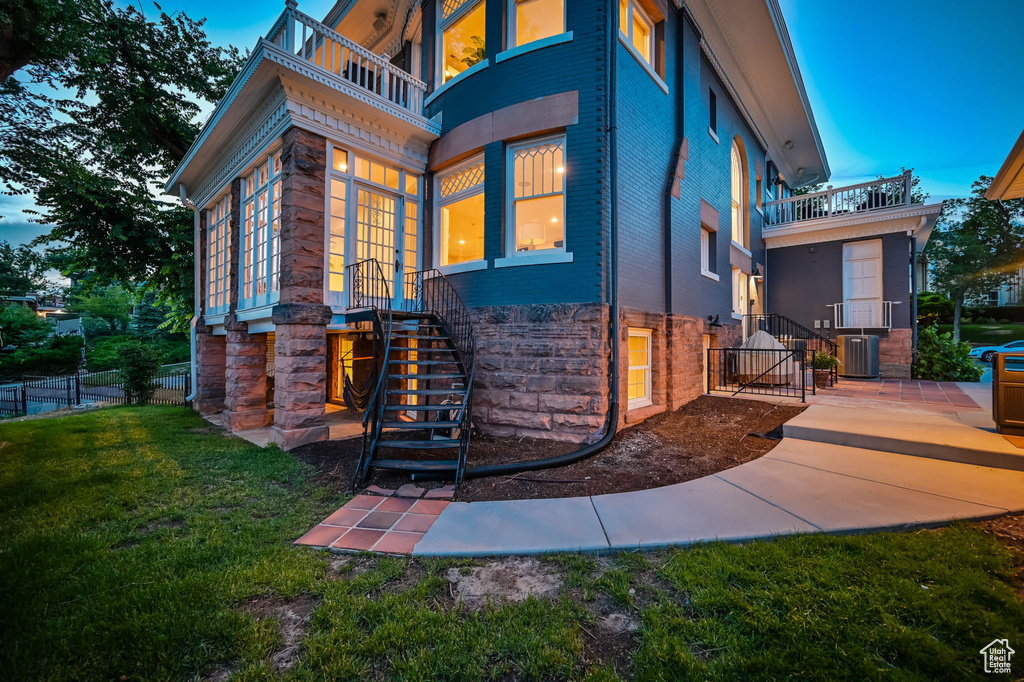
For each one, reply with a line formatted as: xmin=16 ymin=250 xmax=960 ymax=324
xmin=292 ymin=395 xmax=805 ymax=502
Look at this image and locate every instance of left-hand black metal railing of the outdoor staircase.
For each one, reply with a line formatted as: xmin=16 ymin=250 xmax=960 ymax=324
xmin=346 ymin=258 xmax=394 ymax=481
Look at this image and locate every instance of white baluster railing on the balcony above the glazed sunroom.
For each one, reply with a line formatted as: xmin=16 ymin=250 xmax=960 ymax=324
xmin=266 ymin=0 xmax=427 ymax=114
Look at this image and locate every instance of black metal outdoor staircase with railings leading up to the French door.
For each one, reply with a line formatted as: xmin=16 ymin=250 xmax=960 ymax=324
xmin=348 ymin=260 xmax=476 ymax=495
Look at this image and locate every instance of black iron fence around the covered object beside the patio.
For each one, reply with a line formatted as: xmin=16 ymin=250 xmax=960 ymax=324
xmin=708 ymin=348 xmax=815 ymax=401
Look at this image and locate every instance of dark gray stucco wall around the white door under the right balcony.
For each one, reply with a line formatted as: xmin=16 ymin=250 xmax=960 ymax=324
xmin=766 ymin=232 xmax=911 ymax=336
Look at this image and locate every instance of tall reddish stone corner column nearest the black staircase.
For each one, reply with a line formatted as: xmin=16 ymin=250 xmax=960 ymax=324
xmin=270 ymin=128 xmax=332 ymax=450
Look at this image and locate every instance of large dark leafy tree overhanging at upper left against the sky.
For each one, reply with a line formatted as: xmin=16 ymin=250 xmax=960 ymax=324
xmin=0 ymin=0 xmax=241 ymax=327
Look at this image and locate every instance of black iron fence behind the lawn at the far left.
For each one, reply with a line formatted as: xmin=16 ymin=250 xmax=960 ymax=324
xmin=0 ymin=371 xmax=191 ymax=417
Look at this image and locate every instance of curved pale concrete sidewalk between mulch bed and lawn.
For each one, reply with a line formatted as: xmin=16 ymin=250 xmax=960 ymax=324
xmin=413 ymin=404 xmax=1024 ymax=556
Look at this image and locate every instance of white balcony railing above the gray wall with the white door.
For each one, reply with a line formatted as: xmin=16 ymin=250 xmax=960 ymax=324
xmin=764 ymin=171 xmax=911 ymax=227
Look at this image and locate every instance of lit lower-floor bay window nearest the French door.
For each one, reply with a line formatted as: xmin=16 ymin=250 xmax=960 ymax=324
xmin=436 ymin=156 xmax=484 ymax=266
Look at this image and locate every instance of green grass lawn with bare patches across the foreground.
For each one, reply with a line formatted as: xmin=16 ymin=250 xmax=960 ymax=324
xmin=0 ymin=408 xmax=1024 ymax=680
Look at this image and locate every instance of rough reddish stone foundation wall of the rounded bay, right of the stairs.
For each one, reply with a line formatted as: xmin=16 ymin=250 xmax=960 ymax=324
xmin=473 ymin=303 xmax=610 ymax=442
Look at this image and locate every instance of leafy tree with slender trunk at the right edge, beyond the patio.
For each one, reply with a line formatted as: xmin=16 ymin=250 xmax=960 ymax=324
xmin=925 ymin=175 xmax=1024 ymax=341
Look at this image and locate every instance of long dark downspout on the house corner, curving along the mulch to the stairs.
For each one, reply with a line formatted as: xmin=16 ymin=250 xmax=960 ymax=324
xmin=413 ymin=3 xmax=621 ymax=480
